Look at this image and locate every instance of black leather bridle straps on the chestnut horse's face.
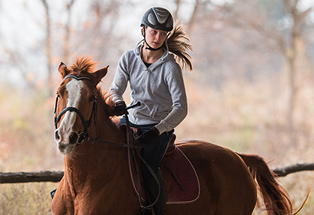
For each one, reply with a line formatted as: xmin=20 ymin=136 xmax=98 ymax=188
xmin=54 ymin=74 xmax=97 ymax=144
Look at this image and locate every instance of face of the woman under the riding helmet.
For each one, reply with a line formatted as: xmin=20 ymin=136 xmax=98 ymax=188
xmin=143 ymin=26 xmax=168 ymax=49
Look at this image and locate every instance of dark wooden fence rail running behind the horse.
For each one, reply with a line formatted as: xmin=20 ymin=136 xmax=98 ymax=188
xmin=0 ymin=163 xmax=314 ymax=184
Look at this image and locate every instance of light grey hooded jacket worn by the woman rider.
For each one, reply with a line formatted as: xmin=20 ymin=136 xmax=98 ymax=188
xmin=110 ymin=45 xmax=187 ymax=134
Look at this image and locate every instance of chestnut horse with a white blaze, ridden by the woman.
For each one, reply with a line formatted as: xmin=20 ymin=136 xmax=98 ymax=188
xmin=51 ymin=58 xmax=293 ymax=215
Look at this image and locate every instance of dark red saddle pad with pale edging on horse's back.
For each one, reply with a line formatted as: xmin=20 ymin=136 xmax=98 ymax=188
xmin=124 ymin=128 xmax=200 ymax=204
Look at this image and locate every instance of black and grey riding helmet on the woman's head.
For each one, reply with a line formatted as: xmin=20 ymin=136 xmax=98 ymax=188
xmin=141 ymin=7 xmax=173 ymax=31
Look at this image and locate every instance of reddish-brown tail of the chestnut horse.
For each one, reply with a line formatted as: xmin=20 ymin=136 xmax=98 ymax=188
xmin=239 ymin=154 xmax=293 ymax=215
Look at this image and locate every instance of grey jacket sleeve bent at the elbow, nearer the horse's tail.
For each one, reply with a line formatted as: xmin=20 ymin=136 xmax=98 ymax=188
xmin=156 ymin=64 xmax=188 ymax=134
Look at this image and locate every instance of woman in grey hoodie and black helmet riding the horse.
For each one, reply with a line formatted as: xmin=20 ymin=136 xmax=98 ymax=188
xmin=110 ymin=7 xmax=192 ymax=215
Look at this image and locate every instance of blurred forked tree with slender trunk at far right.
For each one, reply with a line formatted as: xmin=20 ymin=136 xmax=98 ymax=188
xmin=229 ymin=0 xmax=313 ymax=143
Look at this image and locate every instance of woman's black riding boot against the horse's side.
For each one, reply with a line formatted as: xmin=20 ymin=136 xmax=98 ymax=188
xmin=146 ymin=170 xmax=167 ymax=215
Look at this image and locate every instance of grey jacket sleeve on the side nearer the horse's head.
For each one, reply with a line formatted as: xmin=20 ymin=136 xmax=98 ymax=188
xmin=110 ymin=52 xmax=129 ymax=102
